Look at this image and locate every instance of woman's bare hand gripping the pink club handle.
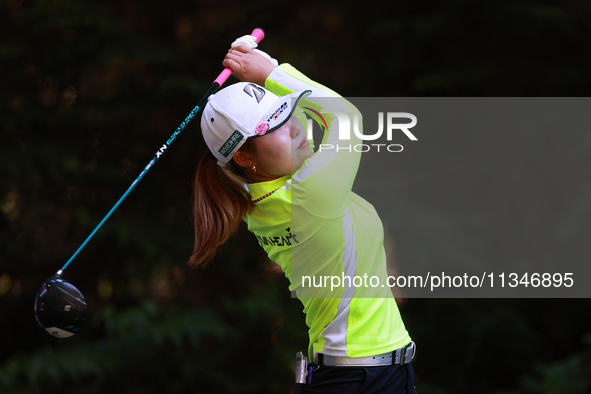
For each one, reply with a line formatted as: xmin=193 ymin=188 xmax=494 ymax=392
xmin=222 ymin=45 xmax=276 ymax=86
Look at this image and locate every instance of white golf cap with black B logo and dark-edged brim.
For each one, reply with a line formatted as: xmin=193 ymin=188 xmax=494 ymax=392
xmin=201 ymin=82 xmax=312 ymax=165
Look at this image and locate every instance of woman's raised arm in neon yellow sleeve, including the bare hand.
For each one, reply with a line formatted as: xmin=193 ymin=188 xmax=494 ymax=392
xmin=223 ymin=46 xmax=362 ymax=217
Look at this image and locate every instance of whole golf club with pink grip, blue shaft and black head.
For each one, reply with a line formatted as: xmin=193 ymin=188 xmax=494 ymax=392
xmin=35 ymin=28 xmax=265 ymax=338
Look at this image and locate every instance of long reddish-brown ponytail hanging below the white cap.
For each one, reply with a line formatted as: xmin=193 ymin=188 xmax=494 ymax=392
xmin=189 ymin=140 xmax=256 ymax=266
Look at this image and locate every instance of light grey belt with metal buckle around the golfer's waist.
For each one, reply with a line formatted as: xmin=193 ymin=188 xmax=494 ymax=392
xmin=314 ymin=341 xmax=416 ymax=367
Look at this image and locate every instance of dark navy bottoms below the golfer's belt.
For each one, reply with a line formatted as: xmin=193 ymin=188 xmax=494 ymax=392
xmin=293 ymin=363 xmax=416 ymax=394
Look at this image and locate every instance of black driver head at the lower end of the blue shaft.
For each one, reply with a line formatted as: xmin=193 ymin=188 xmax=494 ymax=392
xmin=35 ymin=275 xmax=86 ymax=338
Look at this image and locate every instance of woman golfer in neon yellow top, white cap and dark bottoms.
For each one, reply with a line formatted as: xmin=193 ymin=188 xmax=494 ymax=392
xmin=190 ymin=36 xmax=415 ymax=394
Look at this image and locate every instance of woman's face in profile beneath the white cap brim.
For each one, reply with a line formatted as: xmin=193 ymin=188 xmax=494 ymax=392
xmin=253 ymin=116 xmax=312 ymax=178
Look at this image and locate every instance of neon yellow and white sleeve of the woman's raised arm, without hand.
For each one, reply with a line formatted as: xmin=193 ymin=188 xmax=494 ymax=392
xmin=265 ymin=64 xmax=363 ymax=218
